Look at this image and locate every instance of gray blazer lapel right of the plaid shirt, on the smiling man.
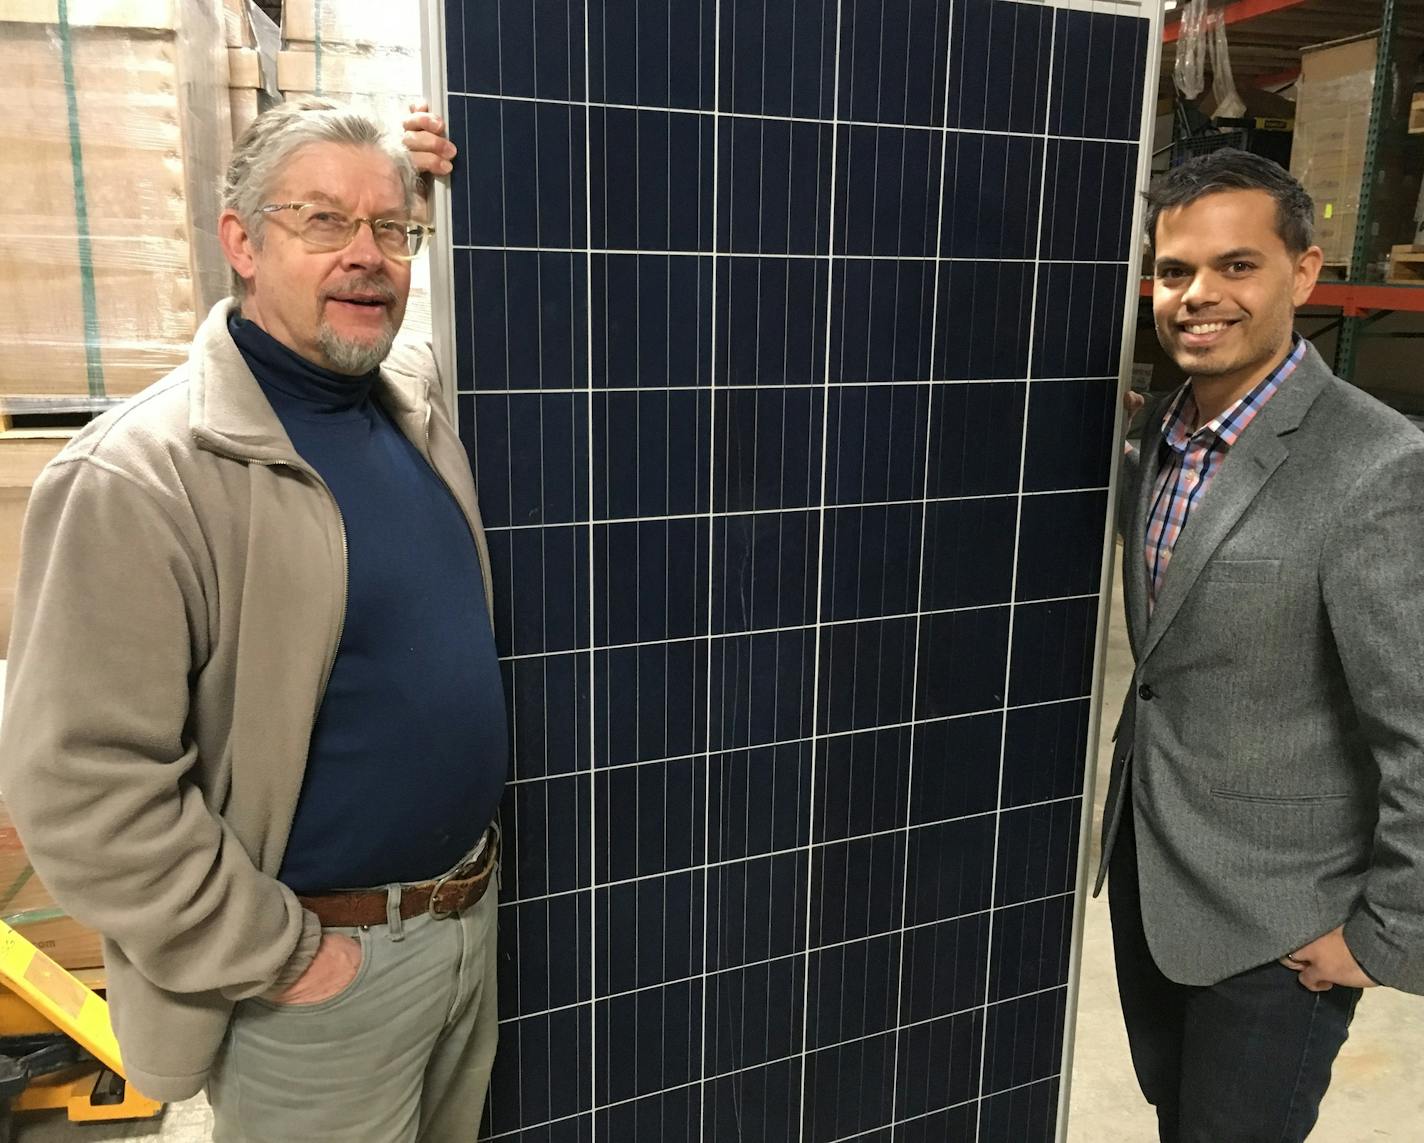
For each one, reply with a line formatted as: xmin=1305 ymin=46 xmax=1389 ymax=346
xmin=1138 ymin=346 xmax=1331 ymax=663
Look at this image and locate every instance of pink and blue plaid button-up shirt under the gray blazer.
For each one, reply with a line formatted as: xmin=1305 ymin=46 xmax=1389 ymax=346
xmin=1146 ymin=335 xmax=1306 ymax=606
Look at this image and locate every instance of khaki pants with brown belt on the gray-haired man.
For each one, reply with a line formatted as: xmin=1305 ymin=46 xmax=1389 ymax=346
xmin=208 ymin=884 xmax=498 ymax=1143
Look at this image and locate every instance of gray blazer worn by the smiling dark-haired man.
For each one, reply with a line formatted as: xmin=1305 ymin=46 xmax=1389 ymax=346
xmin=1094 ymin=347 xmax=1424 ymax=994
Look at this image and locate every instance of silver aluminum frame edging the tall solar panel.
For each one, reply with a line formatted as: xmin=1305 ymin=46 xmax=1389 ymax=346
xmin=420 ymin=0 xmax=1163 ymax=1143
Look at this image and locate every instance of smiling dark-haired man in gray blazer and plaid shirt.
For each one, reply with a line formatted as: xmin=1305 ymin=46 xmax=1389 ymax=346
xmin=1098 ymin=151 xmax=1424 ymax=1143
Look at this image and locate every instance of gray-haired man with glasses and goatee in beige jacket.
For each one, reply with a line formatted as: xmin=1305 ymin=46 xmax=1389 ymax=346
xmin=0 ymin=101 xmax=507 ymax=1143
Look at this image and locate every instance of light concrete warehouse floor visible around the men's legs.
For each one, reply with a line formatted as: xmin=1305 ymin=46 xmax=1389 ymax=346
xmin=16 ymin=566 xmax=1424 ymax=1143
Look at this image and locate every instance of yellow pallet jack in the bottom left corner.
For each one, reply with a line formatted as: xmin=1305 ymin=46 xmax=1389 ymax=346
xmin=0 ymin=921 xmax=164 ymax=1143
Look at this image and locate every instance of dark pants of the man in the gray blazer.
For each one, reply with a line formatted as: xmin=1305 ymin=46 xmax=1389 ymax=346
xmin=1108 ymin=807 xmax=1360 ymax=1143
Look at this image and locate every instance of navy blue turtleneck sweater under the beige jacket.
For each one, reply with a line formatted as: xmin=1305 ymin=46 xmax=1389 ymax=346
xmin=229 ymin=317 xmax=508 ymax=892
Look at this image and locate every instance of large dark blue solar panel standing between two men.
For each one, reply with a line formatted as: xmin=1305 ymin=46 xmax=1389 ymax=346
xmin=421 ymin=0 xmax=1156 ymax=1143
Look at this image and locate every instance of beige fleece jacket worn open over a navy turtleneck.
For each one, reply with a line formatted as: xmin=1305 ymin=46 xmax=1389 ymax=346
xmin=0 ymin=302 xmax=490 ymax=1100
